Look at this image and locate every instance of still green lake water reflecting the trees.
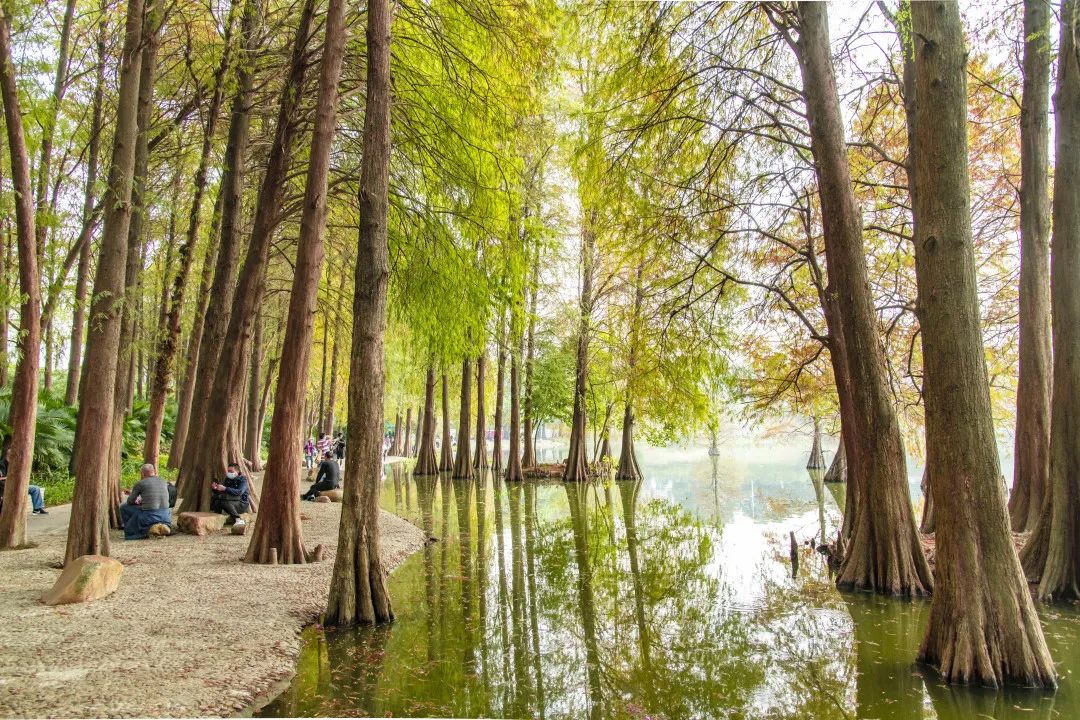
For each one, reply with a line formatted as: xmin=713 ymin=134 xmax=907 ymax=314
xmin=259 ymin=446 xmax=1080 ymax=720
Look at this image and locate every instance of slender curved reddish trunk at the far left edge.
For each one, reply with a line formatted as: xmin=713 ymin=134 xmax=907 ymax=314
xmin=0 ymin=6 xmax=41 ymax=548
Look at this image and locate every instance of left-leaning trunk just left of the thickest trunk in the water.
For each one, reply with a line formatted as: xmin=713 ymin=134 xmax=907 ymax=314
xmin=795 ymin=2 xmax=933 ymax=596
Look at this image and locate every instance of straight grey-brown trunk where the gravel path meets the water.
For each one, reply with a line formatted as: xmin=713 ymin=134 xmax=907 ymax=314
xmin=326 ymin=0 xmax=394 ymax=625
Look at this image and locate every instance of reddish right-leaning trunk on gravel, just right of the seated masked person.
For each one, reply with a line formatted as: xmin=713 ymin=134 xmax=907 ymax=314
xmin=245 ymin=0 xmax=345 ymax=565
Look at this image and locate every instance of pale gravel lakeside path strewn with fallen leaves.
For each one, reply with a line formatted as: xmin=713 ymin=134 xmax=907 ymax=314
xmin=0 ymin=470 xmax=423 ymax=717
